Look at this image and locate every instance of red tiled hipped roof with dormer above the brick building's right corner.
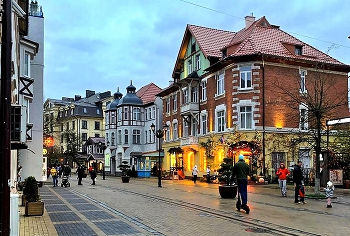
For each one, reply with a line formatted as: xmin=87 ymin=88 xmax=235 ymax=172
xmin=227 ymin=17 xmax=344 ymax=65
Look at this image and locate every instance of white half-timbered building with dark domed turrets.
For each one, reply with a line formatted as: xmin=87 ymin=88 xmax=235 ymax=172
xmin=105 ymin=83 xmax=164 ymax=177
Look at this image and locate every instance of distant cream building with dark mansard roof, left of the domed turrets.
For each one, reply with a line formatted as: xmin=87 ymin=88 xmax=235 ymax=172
xmin=44 ymin=90 xmax=112 ymax=165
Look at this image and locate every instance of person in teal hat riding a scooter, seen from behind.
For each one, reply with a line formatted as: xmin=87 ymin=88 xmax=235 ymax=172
xmin=233 ymin=154 xmax=250 ymax=214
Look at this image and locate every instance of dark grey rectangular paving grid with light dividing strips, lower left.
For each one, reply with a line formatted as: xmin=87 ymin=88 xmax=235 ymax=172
xmin=40 ymin=186 xmax=140 ymax=236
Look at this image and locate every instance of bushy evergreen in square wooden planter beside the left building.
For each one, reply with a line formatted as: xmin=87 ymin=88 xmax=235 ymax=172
xmin=23 ymin=176 xmax=44 ymax=216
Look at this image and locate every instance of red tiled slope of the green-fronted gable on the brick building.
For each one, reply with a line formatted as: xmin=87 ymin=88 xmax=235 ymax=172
xmin=187 ymin=25 xmax=235 ymax=57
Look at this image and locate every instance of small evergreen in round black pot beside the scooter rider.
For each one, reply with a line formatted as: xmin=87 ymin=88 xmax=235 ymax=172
xmin=218 ymin=157 xmax=237 ymax=198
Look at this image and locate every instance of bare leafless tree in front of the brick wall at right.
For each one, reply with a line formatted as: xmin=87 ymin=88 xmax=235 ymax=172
xmin=272 ymin=63 xmax=348 ymax=194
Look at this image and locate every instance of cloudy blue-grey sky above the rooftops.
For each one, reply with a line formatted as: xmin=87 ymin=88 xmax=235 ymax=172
xmin=38 ymin=0 xmax=350 ymax=100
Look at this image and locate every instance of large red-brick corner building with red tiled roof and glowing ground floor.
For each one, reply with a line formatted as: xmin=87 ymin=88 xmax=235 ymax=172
xmin=158 ymin=16 xmax=350 ymax=181
